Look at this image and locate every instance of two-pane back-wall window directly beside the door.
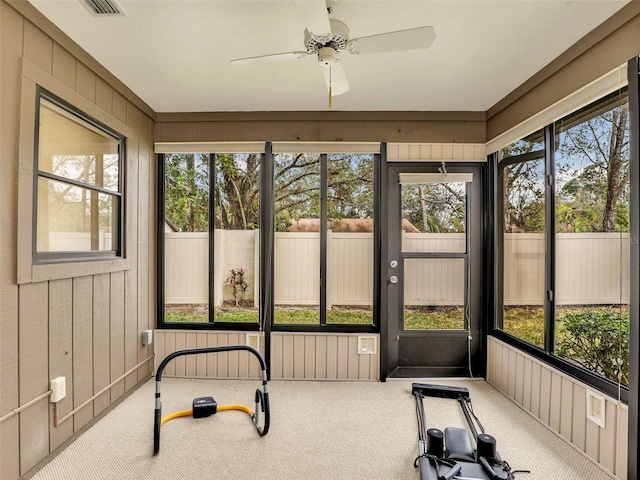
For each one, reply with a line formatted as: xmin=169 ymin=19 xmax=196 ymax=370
xmin=274 ymin=153 xmax=374 ymax=326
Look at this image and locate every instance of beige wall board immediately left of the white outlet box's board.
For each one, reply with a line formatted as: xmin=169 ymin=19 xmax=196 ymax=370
xmin=19 ymin=283 xmax=49 ymax=473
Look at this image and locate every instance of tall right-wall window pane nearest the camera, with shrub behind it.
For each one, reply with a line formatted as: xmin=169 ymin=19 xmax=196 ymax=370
xmin=554 ymin=91 xmax=630 ymax=387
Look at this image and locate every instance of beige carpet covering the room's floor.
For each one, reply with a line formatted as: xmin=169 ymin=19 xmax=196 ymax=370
xmin=28 ymin=378 xmax=611 ymax=480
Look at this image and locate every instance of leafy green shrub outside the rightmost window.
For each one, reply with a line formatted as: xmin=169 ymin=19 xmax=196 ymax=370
xmin=556 ymin=310 xmax=629 ymax=386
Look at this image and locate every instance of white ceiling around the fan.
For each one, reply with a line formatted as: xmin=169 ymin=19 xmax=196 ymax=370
xmin=29 ymin=0 xmax=628 ymax=112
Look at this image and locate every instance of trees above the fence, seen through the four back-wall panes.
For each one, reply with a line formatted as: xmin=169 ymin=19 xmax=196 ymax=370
xmin=165 ymin=153 xmax=380 ymax=232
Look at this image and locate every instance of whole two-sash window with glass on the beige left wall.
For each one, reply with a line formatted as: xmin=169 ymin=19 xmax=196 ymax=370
xmin=34 ymin=90 xmax=124 ymax=263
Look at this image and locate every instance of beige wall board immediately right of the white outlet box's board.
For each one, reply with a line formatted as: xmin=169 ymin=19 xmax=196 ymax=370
xmin=73 ymin=277 xmax=94 ymax=432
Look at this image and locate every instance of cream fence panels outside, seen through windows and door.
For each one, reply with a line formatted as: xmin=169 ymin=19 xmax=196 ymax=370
xmin=165 ymin=231 xmax=629 ymax=306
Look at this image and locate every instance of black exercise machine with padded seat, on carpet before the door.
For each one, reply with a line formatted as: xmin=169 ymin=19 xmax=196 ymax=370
xmin=411 ymin=383 xmax=526 ymax=480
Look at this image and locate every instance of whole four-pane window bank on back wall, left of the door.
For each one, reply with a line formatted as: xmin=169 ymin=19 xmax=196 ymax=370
xmin=158 ymin=143 xmax=380 ymax=331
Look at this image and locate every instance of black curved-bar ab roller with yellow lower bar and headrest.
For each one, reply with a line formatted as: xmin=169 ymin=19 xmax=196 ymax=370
xmin=153 ymin=345 xmax=271 ymax=455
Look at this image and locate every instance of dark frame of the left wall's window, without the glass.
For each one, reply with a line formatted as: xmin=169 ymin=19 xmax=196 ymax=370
xmin=32 ymin=86 xmax=127 ymax=264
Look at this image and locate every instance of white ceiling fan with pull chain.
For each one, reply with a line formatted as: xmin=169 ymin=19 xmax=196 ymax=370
xmin=231 ymin=0 xmax=436 ymax=108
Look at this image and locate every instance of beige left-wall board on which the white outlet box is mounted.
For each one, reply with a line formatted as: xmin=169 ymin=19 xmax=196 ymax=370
xmin=49 ymin=279 xmax=73 ymax=450
